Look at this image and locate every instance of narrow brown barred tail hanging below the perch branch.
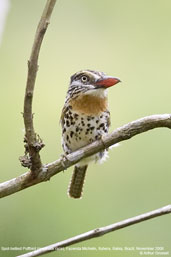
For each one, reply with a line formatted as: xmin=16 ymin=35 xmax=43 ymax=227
xmin=68 ymin=165 xmax=88 ymax=199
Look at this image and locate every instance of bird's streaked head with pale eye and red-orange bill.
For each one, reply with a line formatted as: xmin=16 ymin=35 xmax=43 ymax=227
xmin=68 ymin=70 xmax=120 ymax=97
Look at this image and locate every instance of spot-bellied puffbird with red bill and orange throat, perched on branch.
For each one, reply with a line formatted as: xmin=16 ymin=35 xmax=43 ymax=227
xmin=60 ymin=70 xmax=120 ymax=199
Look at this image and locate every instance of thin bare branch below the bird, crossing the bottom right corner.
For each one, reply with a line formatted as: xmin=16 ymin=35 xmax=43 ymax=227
xmin=18 ymin=205 xmax=171 ymax=257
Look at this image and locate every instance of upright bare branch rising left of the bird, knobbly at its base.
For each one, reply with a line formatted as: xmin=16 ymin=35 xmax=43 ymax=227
xmin=20 ymin=0 xmax=56 ymax=174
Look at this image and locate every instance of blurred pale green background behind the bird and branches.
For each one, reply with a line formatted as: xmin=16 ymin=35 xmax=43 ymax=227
xmin=0 ymin=0 xmax=171 ymax=257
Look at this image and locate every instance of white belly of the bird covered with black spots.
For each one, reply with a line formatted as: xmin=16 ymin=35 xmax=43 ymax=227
xmin=62 ymin=110 xmax=110 ymax=163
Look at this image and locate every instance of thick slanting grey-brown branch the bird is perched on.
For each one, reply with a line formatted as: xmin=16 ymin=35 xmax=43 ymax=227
xmin=0 ymin=114 xmax=171 ymax=197
